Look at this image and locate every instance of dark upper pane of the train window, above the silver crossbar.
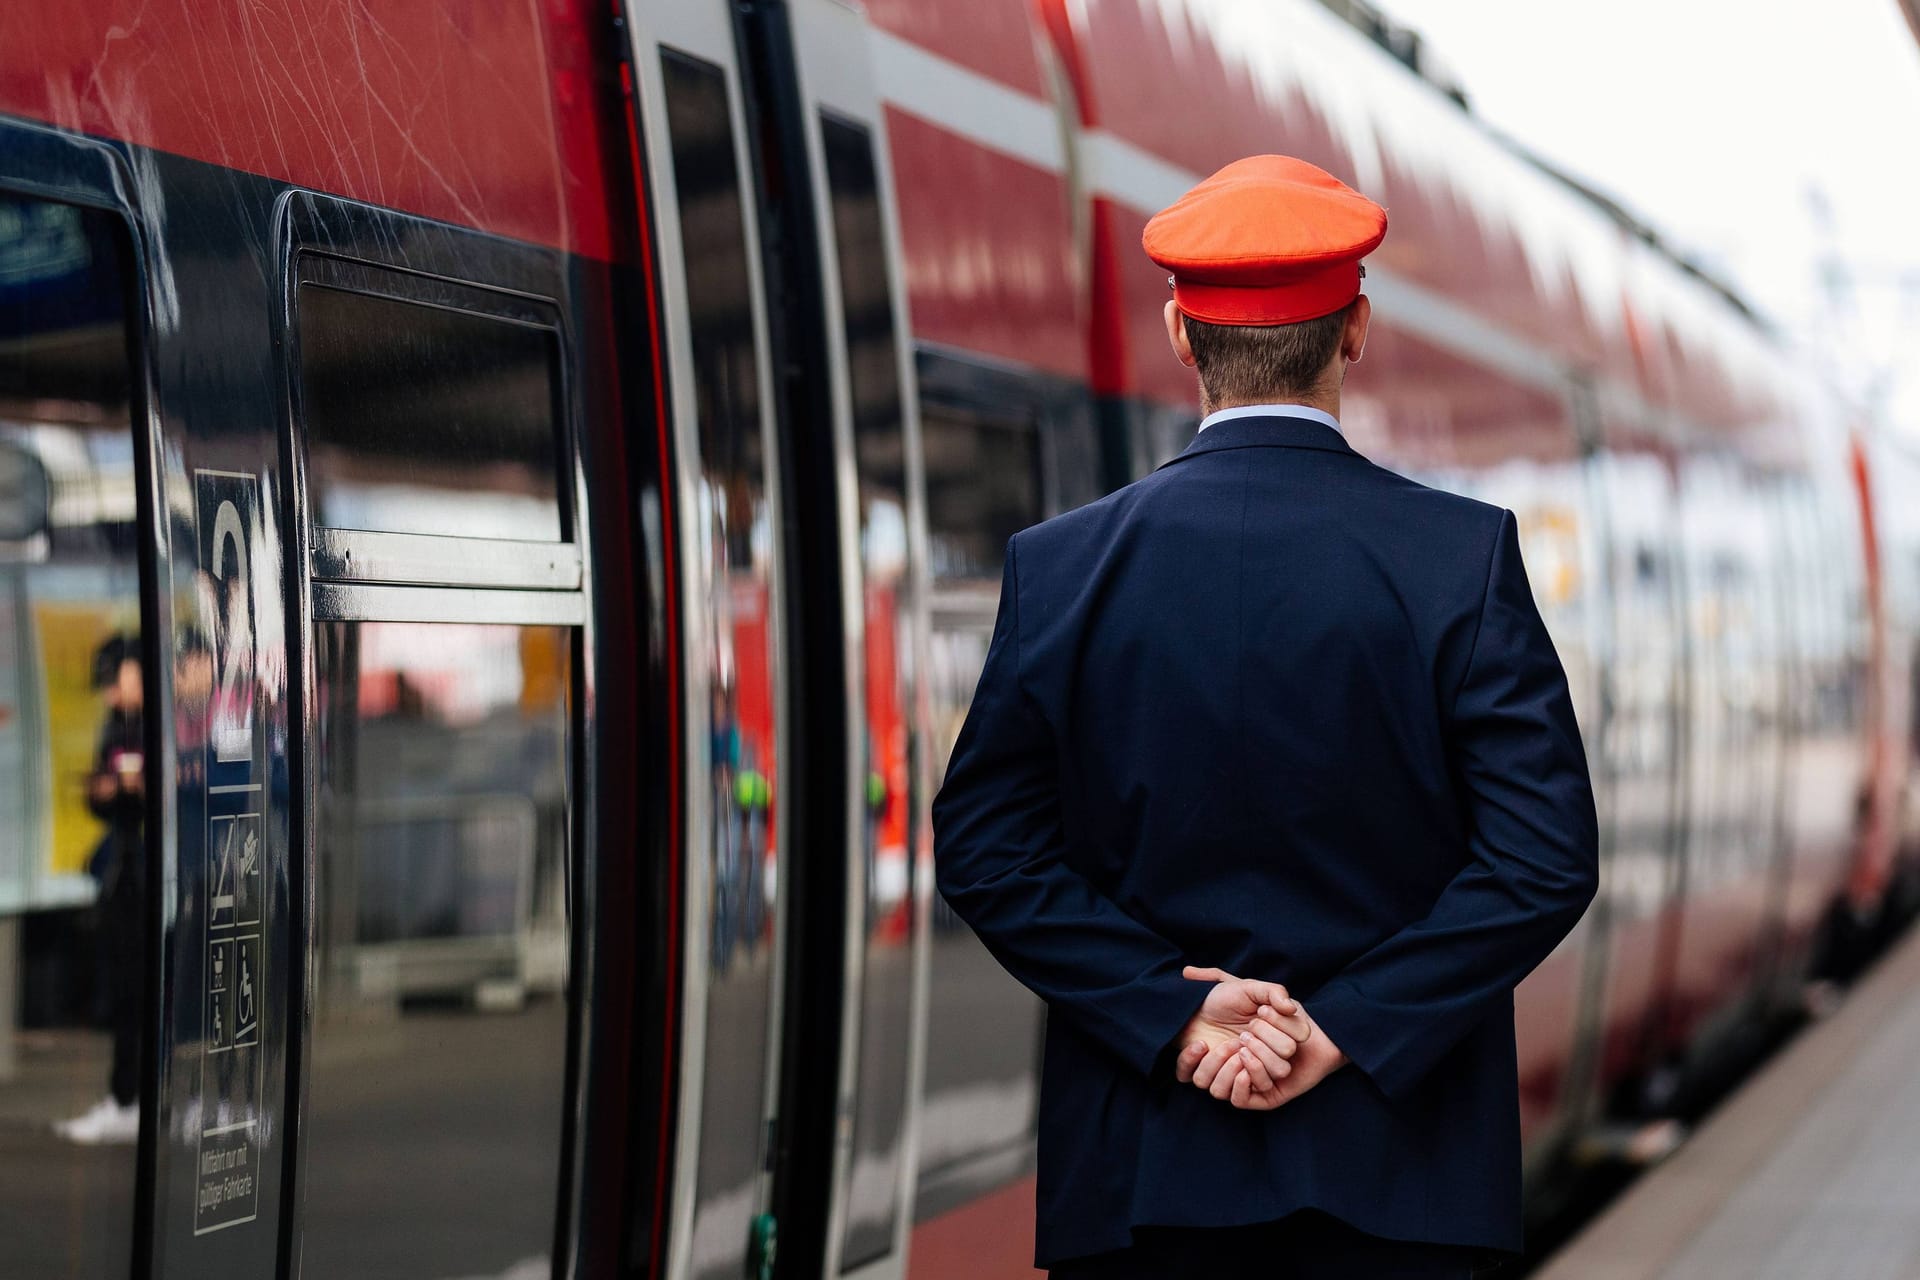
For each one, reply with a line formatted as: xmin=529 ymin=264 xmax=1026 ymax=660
xmin=298 ymin=284 xmax=564 ymax=541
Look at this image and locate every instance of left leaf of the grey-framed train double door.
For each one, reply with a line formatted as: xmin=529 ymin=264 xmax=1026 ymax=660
xmin=628 ymin=0 xmax=797 ymax=1276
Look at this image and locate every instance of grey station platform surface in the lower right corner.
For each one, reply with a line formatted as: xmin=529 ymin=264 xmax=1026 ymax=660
xmin=1534 ymin=931 xmax=1920 ymax=1280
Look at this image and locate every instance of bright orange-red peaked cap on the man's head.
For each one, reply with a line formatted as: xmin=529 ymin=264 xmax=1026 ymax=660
xmin=1140 ymin=155 xmax=1386 ymax=324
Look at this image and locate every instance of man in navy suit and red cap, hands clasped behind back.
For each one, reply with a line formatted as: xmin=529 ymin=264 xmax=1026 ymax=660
xmin=933 ymin=155 xmax=1597 ymax=1280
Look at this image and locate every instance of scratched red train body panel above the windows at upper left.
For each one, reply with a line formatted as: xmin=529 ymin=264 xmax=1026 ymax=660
xmin=0 ymin=0 xmax=634 ymax=259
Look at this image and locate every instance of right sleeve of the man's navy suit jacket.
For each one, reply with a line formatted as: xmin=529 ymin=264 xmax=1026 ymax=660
xmin=1304 ymin=512 xmax=1599 ymax=1098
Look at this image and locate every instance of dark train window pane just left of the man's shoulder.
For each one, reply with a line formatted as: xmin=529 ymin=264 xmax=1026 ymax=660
xmin=920 ymin=401 xmax=1041 ymax=585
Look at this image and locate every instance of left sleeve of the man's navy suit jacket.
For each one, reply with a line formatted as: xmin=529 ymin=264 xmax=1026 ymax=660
xmin=933 ymin=541 xmax=1210 ymax=1075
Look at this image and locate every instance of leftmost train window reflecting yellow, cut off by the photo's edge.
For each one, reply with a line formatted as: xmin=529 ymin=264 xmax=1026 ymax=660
xmin=0 ymin=194 xmax=150 ymax=1276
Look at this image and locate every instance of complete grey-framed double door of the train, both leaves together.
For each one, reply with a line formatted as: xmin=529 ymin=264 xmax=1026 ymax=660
xmin=628 ymin=0 xmax=927 ymax=1276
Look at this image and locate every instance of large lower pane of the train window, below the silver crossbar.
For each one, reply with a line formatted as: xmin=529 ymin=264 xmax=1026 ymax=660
xmin=301 ymin=622 xmax=574 ymax=1280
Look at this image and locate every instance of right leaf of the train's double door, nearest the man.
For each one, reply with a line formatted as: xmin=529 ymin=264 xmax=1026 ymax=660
xmin=762 ymin=10 xmax=931 ymax=1276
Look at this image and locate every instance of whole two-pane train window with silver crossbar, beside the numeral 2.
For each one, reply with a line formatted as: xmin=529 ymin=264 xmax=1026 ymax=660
xmin=294 ymin=255 xmax=586 ymax=1280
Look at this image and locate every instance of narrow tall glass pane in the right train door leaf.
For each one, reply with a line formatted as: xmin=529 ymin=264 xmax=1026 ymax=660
xmin=820 ymin=115 xmax=920 ymax=1268
